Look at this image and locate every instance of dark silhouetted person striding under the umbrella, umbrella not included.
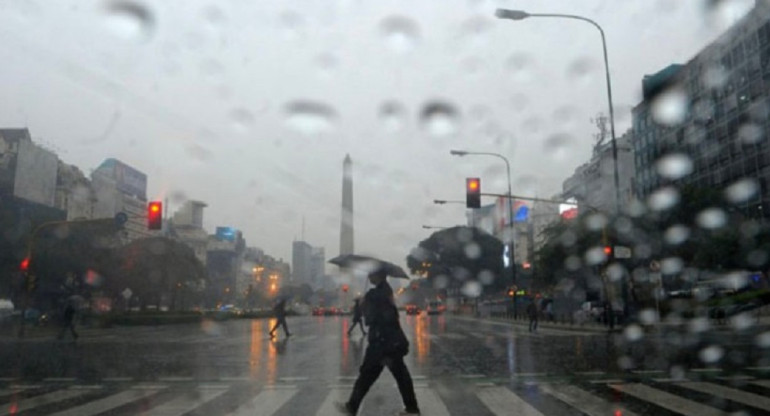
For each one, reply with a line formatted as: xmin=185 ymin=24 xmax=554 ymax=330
xmin=336 ymin=269 xmax=420 ymax=415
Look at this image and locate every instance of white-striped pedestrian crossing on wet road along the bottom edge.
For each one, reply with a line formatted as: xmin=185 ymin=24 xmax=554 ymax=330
xmin=0 ymin=376 xmax=770 ymax=416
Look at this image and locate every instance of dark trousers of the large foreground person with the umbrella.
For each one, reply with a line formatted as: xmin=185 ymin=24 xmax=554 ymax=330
xmin=348 ymin=344 xmax=419 ymax=413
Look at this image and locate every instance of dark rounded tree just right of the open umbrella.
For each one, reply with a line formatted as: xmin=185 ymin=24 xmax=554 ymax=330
xmin=406 ymin=226 xmax=509 ymax=292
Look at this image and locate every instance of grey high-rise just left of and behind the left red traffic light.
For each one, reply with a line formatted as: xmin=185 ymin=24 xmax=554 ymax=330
xmin=91 ymin=159 xmax=152 ymax=241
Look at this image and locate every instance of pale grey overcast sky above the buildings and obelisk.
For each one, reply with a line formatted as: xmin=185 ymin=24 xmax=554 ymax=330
xmin=0 ymin=0 xmax=753 ymax=272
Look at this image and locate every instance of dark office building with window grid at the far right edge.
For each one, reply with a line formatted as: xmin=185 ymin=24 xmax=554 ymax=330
xmin=633 ymin=1 xmax=770 ymax=218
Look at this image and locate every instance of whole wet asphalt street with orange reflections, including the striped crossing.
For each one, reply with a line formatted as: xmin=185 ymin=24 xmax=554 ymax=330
xmin=0 ymin=314 xmax=770 ymax=416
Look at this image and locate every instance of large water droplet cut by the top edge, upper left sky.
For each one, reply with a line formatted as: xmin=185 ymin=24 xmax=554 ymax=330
xmin=105 ymin=0 xmax=155 ymax=42
